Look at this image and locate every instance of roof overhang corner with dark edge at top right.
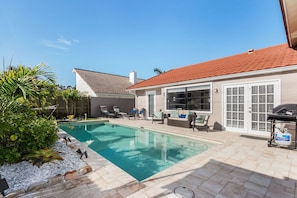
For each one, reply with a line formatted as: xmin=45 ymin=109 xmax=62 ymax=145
xmin=279 ymin=0 xmax=297 ymax=50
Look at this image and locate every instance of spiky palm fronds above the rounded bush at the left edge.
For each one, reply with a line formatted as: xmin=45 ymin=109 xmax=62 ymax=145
xmin=0 ymin=64 xmax=55 ymax=113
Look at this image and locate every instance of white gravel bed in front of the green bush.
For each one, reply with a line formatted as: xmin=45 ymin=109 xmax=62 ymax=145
xmin=0 ymin=141 xmax=87 ymax=194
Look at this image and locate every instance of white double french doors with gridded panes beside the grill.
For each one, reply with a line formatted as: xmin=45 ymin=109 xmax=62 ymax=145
xmin=224 ymin=81 xmax=279 ymax=135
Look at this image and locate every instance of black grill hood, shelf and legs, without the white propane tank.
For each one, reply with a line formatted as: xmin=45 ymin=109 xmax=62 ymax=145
xmin=267 ymin=104 xmax=297 ymax=149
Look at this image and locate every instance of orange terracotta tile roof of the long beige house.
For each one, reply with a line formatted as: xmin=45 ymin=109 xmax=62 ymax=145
xmin=127 ymin=44 xmax=297 ymax=89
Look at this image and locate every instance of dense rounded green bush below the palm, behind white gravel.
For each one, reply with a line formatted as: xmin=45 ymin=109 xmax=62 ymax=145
xmin=0 ymin=110 xmax=58 ymax=165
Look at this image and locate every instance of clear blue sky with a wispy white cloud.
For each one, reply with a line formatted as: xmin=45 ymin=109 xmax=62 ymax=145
xmin=0 ymin=0 xmax=287 ymax=86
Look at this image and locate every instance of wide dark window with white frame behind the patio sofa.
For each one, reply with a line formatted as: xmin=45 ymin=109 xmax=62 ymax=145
xmin=166 ymin=85 xmax=210 ymax=111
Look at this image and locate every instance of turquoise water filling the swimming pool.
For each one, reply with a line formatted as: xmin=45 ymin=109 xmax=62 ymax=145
xmin=59 ymin=122 xmax=216 ymax=181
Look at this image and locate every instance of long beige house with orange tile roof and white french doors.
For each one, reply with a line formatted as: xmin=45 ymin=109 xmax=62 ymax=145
xmin=127 ymin=44 xmax=297 ymax=135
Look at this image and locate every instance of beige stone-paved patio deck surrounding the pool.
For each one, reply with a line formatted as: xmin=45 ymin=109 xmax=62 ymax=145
xmin=14 ymin=119 xmax=297 ymax=198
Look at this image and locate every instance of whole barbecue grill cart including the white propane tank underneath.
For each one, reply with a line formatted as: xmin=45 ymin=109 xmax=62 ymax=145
xmin=267 ymin=104 xmax=297 ymax=149
